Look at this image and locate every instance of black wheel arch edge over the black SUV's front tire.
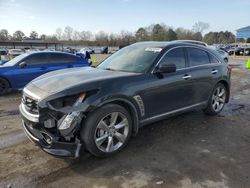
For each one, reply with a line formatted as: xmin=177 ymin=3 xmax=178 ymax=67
xmin=95 ymin=98 xmax=139 ymax=136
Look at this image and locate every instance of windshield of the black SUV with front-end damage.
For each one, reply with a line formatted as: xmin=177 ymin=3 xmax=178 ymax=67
xmin=97 ymin=44 xmax=162 ymax=73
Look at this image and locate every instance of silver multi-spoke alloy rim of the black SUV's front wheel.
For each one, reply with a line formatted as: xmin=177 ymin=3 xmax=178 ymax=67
xmin=94 ymin=112 xmax=129 ymax=153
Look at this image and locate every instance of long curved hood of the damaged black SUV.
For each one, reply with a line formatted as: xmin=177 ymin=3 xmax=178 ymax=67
xmin=30 ymin=67 xmax=138 ymax=93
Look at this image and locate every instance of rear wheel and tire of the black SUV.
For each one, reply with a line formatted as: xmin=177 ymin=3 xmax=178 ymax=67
xmin=204 ymin=83 xmax=228 ymax=115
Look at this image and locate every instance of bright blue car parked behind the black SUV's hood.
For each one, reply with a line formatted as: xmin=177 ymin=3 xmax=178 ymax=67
xmin=0 ymin=52 xmax=89 ymax=95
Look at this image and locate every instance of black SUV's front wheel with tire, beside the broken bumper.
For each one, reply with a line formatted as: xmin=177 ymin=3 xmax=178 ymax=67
xmin=81 ymin=104 xmax=132 ymax=157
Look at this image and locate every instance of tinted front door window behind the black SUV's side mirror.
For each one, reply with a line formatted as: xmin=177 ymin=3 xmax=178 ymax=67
xmin=160 ymin=48 xmax=186 ymax=69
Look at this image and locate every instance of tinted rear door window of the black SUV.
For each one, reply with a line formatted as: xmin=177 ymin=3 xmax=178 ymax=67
xmin=187 ymin=48 xmax=210 ymax=67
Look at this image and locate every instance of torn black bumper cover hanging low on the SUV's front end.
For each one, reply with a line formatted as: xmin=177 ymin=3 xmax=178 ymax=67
xmin=19 ymin=106 xmax=81 ymax=158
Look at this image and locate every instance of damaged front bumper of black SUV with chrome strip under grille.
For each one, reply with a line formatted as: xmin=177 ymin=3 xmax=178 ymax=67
xmin=19 ymin=99 xmax=87 ymax=158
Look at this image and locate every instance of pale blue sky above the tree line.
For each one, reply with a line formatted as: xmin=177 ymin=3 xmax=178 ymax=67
xmin=0 ymin=0 xmax=250 ymax=35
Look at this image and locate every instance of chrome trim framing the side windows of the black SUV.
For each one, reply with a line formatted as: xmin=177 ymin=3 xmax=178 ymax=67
xmin=151 ymin=45 xmax=221 ymax=74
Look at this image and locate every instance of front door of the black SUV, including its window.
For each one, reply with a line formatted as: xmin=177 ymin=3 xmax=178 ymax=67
xmin=141 ymin=47 xmax=195 ymax=118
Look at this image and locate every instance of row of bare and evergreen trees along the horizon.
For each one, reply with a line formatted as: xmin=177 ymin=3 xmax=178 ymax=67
xmin=0 ymin=22 xmax=238 ymax=46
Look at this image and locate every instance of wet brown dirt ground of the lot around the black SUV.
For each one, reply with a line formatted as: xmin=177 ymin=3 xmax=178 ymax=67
xmin=0 ymin=57 xmax=250 ymax=188
